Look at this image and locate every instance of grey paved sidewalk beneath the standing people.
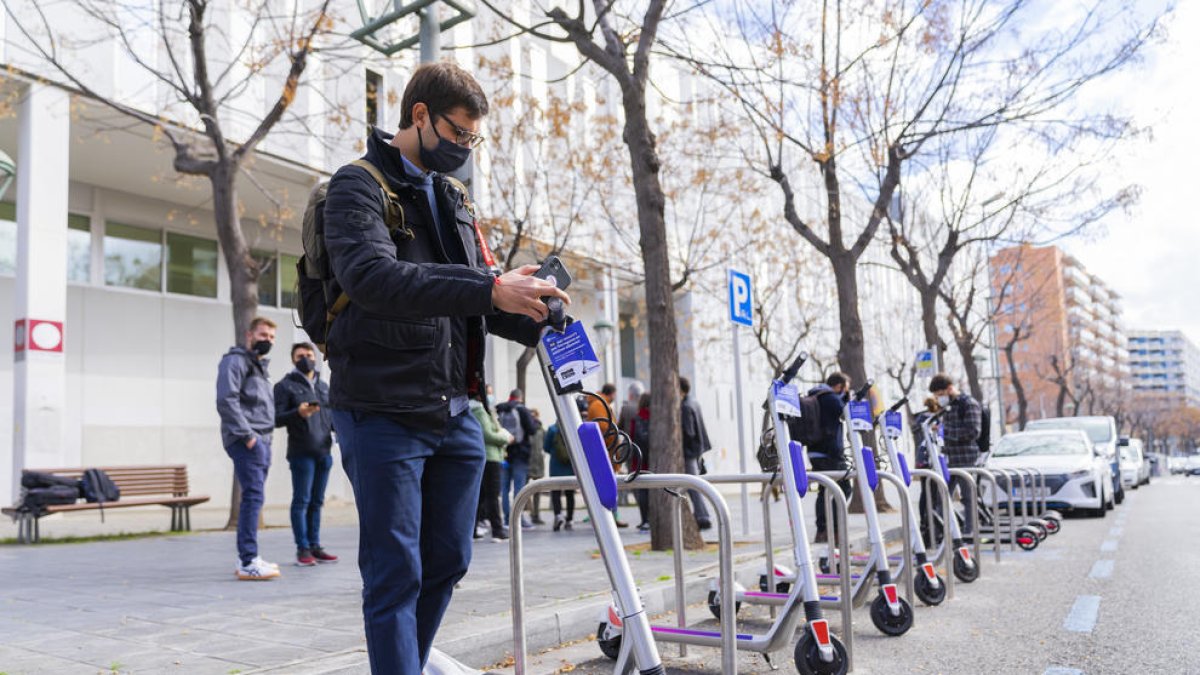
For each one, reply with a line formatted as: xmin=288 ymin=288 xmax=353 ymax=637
xmin=0 ymin=480 xmax=896 ymax=675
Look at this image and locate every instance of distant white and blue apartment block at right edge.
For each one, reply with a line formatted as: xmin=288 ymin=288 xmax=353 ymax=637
xmin=1129 ymin=330 xmax=1200 ymax=408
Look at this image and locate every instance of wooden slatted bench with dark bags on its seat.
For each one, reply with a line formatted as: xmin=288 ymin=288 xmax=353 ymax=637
xmin=0 ymin=465 xmax=209 ymax=544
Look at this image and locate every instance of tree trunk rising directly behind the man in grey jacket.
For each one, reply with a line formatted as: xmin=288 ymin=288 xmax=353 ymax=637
xmin=209 ymin=162 xmax=263 ymax=530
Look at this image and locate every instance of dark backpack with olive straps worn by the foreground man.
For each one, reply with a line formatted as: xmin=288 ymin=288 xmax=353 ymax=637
xmin=295 ymin=160 xmax=408 ymax=352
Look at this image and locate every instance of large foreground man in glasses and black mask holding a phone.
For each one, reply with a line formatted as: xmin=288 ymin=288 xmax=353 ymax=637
xmin=324 ymin=62 xmax=569 ymax=675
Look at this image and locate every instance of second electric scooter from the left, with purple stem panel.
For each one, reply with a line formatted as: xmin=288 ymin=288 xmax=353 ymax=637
xmin=596 ymin=354 xmax=850 ymax=675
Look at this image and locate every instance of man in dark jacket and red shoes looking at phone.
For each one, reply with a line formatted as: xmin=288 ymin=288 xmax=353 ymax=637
xmin=275 ymin=342 xmax=337 ymax=567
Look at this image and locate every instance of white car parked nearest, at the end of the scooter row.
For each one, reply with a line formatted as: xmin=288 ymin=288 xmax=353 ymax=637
xmin=984 ymin=429 xmax=1112 ymax=518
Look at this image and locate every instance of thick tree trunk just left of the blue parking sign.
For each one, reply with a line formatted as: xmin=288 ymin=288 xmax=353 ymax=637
xmin=622 ymin=82 xmax=704 ymax=551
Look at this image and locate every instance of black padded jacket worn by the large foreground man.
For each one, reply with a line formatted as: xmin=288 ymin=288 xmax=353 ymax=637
xmin=324 ymin=130 xmax=538 ymax=430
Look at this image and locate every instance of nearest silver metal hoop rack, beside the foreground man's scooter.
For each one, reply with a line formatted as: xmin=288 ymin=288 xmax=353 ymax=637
xmin=509 ymin=473 xmax=738 ymax=675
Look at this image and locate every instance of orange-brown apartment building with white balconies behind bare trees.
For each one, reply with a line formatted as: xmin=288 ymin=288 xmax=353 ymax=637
xmin=991 ymin=245 xmax=1130 ymax=424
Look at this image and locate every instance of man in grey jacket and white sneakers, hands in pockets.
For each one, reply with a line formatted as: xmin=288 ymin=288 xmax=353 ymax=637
xmin=217 ymin=317 xmax=280 ymax=581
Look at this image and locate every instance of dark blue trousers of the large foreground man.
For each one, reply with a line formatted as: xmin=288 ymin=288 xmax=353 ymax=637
xmin=332 ymin=411 xmax=484 ymax=675
